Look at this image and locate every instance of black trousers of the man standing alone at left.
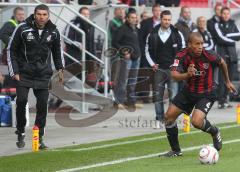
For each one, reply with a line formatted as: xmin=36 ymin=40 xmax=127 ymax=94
xmin=16 ymin=86 xmax=49 ymax=136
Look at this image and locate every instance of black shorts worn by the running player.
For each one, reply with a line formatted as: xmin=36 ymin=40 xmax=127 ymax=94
xmin=172 ymin=91 xmax=214 ymax=115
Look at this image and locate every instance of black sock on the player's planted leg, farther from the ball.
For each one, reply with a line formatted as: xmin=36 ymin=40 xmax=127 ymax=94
xmin=165 ymin=123 xmax=181 ymax=152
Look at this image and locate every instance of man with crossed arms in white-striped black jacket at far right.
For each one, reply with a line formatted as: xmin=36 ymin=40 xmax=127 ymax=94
xmin=212 ymin=7 xmax=240 ymax=109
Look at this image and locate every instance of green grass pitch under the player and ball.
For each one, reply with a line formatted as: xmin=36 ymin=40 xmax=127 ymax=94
xmin=0 ymin=123 xmax=240 ymax=172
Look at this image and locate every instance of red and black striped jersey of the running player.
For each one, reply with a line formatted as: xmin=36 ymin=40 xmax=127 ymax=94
xmin=171 ymin=48 xmax=221 ymax=94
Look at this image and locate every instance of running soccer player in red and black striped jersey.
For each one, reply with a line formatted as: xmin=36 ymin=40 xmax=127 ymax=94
xmin=164 ymin=32 xmax=236 ymax=157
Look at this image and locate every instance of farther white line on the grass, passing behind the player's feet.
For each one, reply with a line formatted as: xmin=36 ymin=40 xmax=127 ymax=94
xmin=52 ymin=124 xmax=240 ymax=151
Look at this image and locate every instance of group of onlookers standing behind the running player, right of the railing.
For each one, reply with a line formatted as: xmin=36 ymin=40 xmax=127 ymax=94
xmin=106 ymin=4 xmax=240 ymax=129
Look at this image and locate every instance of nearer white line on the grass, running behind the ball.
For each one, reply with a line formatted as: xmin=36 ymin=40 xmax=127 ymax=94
xmin=57 ymin=139 xmax=240 ymax=172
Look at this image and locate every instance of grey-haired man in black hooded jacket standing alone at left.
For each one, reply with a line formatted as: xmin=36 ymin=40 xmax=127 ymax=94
xmin=7 ymin=5 xmax=64 ymax=149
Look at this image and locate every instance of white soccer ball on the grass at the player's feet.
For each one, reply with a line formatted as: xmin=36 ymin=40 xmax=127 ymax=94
xmin=199 ymin=146 xmax=219 ymax=164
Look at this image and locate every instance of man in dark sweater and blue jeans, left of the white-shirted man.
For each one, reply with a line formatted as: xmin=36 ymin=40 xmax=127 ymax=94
xmin=113 ymin=8 xmax=141 ymax=109
